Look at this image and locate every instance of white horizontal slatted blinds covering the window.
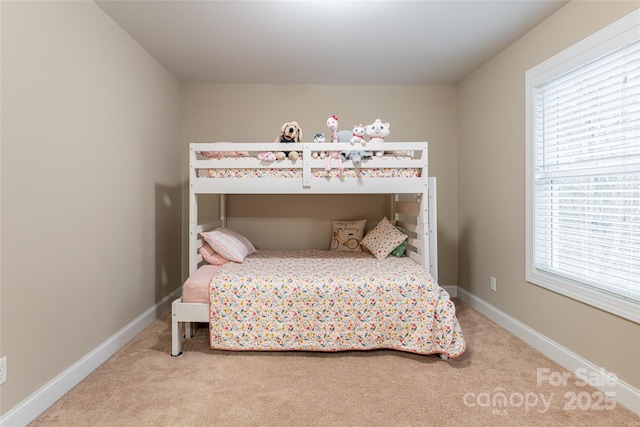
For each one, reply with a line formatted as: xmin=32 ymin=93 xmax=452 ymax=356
xmin=533 ymin=40 xmax=640 ymax=301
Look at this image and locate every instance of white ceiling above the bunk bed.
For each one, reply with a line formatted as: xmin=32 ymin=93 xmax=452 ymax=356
xmin=96 ymin=0 xmax=567 ymax=84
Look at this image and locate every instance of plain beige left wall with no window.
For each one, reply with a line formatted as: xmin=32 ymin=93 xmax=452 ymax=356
xmin=0 ymin=1 xmax=182 ymax=414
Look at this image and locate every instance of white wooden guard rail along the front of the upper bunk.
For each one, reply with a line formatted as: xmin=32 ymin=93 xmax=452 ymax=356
xmin=189 ymin=142 xmax=429 ymax=194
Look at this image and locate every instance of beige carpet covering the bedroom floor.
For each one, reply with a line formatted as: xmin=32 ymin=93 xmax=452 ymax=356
xmin=31 ymin=301 xmax=640 ymax=427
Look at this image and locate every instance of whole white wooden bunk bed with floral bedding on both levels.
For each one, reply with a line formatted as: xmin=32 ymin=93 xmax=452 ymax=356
xmin=171 ymin=142 xmax=466 ymax=359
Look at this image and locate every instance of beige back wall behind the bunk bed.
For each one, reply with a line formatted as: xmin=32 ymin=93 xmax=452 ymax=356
xmin=182 ymin=85 xmax=458 ymax=285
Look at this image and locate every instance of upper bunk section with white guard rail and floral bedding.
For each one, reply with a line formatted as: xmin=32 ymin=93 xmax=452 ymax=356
xmin=190 ymin=142 xmax=428 ymax=194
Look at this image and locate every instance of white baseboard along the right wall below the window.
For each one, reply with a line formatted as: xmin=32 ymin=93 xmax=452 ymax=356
xmin=457 ymin=288 xmax=640 ymax=415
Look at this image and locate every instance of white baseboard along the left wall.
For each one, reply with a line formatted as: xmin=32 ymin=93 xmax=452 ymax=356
xmin=0 ymin=287 xmax=182 ymax=427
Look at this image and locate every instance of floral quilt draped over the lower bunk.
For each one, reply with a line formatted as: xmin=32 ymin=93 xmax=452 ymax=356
xmin=209 ymin=250 xmax=466 ymax=357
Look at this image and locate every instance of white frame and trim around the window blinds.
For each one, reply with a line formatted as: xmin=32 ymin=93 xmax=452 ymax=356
xmin=525 ymin=10 xmax=640 ymax=323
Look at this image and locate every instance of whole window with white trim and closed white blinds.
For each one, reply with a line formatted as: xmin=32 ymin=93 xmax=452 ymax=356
xmin=526 ymin=11 xmax=640 ymax=323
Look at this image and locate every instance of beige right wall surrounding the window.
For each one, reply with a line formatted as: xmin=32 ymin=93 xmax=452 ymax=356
xmin=458 ymin=1 xmax=640 ymax=388
